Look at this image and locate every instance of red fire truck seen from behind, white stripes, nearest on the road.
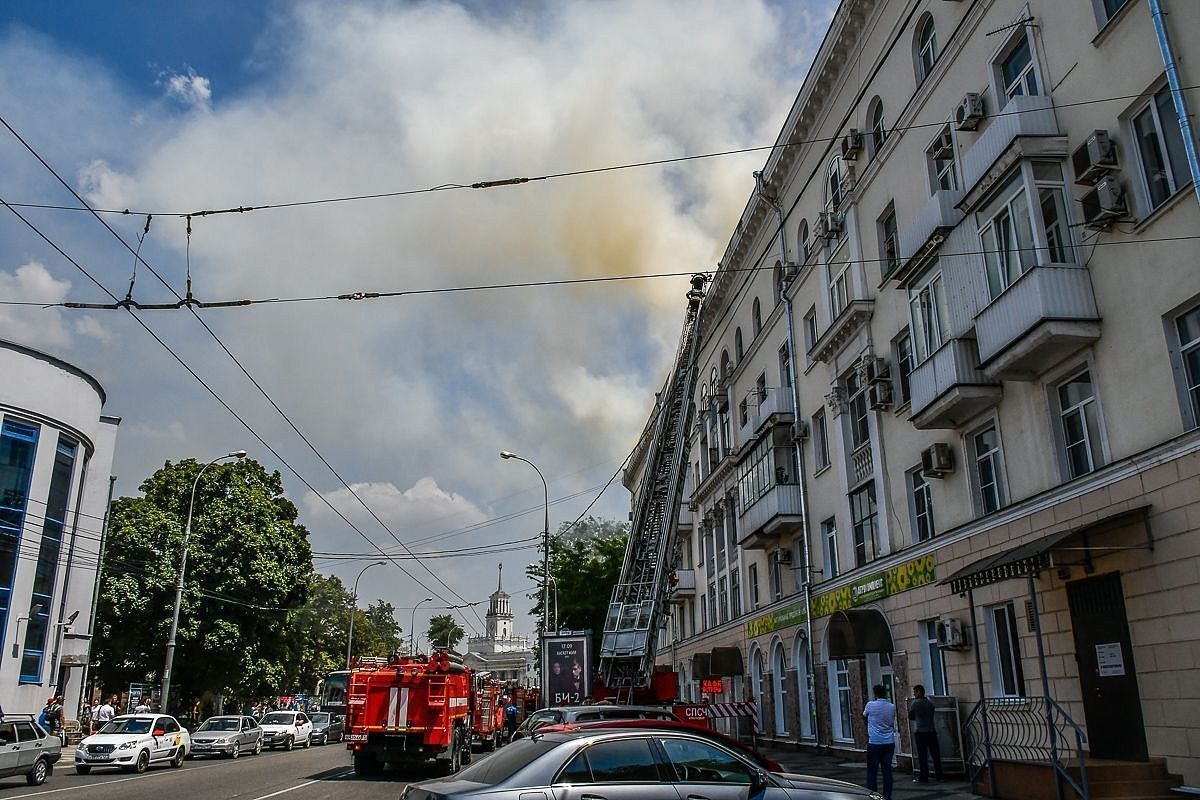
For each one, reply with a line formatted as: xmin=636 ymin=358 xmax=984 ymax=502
xmin=346 ymin=648 xmax=475 ymax=776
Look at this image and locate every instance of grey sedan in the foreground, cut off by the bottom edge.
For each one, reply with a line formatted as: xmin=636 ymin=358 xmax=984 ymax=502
xmin=401 ymin=728 xmax=882 ymax=800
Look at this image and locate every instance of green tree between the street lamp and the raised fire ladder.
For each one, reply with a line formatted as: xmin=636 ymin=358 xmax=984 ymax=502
xmin=526 ymin=517 xmax=629 ymax=652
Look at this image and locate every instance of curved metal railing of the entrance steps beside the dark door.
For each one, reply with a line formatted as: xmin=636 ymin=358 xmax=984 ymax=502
xmin=962 ymin=697 xmax=1092 ymax=800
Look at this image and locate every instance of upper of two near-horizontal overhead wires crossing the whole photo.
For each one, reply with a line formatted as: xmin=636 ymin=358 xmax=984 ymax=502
xmin=0 ymin=84 xmax=1200 ymax=218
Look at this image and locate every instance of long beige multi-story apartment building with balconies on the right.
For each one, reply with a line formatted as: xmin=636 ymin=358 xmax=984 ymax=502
xmin=647 ymin=0 xmax=1200 ymax=783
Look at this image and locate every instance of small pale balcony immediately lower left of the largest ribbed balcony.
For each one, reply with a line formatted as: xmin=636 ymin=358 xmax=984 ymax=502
xmin=908 ymin=339 xmax=1001 ymax=431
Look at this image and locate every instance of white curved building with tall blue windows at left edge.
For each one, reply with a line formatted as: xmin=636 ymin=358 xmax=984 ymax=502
xmin=0 ymin=341 xmax=120 ymax=718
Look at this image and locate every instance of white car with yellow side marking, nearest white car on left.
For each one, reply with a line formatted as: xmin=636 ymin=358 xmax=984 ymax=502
xmin=76 ymin=714 xmax=192 ymax=775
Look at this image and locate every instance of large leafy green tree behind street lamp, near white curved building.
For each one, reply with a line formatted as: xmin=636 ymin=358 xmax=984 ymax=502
xmin=94 ymin=458 xmax=313 ymax=698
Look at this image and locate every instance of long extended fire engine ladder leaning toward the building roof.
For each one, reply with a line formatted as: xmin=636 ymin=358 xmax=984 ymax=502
xmin=599 ymin=275 xmax=707 ymax=698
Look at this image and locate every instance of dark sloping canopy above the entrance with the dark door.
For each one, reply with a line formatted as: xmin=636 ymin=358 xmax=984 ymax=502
xmin=941 ymin=505 xmax=1153 ymax=595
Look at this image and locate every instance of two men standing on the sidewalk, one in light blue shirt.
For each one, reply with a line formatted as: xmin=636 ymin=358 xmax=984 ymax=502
xmin=863 ymin=684 xmax=942 ymax=800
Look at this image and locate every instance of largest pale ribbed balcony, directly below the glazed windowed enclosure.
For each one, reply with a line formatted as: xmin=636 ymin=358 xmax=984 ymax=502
xmin=974 ymin=264 xmax=1100 ymax=380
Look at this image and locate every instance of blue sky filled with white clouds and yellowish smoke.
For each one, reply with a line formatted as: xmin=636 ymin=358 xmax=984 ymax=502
xmin=0 ymin=0 xmax=836 ymax=633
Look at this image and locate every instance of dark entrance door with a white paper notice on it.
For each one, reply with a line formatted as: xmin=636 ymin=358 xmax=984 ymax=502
xmin=1067 ymin=572 xmax=1147 ymax=762
